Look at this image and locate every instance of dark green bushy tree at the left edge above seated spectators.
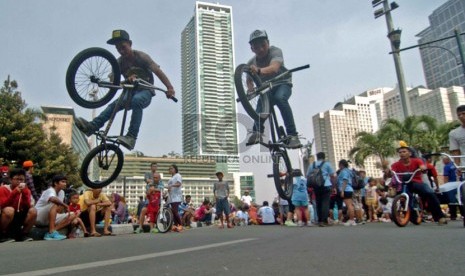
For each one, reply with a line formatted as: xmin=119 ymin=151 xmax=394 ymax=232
xmin=0 ymin=77 xmax=79 ymax=190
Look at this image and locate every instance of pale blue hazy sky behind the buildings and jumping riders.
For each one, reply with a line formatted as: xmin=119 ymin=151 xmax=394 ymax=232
xmin=0 ymin=0 xmax=450 ymax=203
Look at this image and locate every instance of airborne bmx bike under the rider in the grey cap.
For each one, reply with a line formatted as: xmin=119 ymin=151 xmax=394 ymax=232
xmin=234 ymin=64 xmax=310 ymax=200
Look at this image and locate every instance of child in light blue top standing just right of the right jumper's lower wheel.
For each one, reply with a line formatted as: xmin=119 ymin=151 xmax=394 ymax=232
xmin=291 ymin=169 xmax=312 ymax=226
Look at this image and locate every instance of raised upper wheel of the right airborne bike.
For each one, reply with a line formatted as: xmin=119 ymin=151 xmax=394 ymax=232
xmin=234 ymin=64 xmax=270 ymax=121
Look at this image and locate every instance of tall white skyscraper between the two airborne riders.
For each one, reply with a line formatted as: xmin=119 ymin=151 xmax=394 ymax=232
xmin=181 ymin=2 xmax=239 ymax=172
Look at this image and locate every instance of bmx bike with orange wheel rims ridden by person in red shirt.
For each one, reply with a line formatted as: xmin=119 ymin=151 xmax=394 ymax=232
xmin=391 ymin=169 xmax=424 ymax=227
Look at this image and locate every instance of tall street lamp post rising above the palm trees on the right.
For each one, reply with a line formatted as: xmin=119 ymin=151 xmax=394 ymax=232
xmin=371 ymin=0 xmax=411 ymax=118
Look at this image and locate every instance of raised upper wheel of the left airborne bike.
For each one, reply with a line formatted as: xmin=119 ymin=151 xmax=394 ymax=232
xmin=66 ymin=47 xmax=121 ymax=108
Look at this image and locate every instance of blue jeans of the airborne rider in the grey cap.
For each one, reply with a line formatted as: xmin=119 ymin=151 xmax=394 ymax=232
xmin=253 ymin=84 xmax=297 ymax=135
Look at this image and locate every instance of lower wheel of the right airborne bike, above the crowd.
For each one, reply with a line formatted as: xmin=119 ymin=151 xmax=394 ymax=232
xmin=273 ymin=150 xmax=293 ymax=200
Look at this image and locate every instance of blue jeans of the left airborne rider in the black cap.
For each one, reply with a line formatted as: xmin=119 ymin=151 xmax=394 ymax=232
xmin=91 ymin=90 xmax=152 ymax=138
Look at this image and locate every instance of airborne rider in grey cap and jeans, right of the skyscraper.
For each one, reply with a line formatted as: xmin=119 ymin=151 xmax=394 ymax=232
xmin=247 ymin=30 xmax=302 ymax=148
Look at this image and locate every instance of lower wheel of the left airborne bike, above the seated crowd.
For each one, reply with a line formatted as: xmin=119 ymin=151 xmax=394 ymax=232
xmin=80 ymin=144 xmax=124 ymax=189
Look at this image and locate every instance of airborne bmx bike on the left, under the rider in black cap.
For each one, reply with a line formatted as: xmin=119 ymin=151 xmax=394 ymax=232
xmin=66 ymin=47 xmax=178 ymax=188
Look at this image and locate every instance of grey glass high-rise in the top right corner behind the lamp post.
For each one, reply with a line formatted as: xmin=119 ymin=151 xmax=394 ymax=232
xmin=417 ymin=0 xmax=465 ymax=89
